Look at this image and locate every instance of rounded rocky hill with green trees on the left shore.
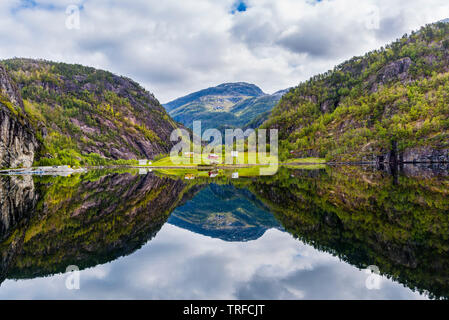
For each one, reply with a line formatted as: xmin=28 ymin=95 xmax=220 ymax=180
xmin=0 ymin=59 xmax=177 ymax=167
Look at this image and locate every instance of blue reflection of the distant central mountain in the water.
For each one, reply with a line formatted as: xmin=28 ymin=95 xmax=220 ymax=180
xmin=168 ymin=184 xmax=279 ymax=241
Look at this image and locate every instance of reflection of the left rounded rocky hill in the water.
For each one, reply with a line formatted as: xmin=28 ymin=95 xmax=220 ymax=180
xmin=0 ymin=172 xmax=186 ymax=278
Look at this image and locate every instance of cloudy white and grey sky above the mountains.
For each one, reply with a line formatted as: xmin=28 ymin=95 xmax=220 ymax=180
xmin=0 ymin=0 xmax=449 ymax=103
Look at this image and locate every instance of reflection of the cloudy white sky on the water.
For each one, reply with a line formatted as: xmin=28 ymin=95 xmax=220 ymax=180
xmin=0 ymin=224 xmax=426 ymax=299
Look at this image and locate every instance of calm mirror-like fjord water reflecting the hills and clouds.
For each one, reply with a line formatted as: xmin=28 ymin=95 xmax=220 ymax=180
xmin=0 ymin=165 xmax=449 ymax=299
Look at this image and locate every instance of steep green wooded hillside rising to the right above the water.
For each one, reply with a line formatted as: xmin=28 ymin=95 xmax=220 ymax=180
xmin=262 ymin=22 xmax=449 ymax=162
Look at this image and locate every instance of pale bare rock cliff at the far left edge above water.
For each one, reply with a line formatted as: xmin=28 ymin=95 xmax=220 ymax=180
xmin=0 ymin=66 xmax=38 ymax=168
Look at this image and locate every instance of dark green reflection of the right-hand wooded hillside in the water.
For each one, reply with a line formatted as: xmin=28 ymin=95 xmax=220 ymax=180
xmin=250 ymin=167 xmax=449 ymax=298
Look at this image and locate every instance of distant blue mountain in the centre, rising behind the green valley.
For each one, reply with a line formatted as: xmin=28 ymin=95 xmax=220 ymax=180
xmin=164 ymin=82 xmax=285 ymax=130
